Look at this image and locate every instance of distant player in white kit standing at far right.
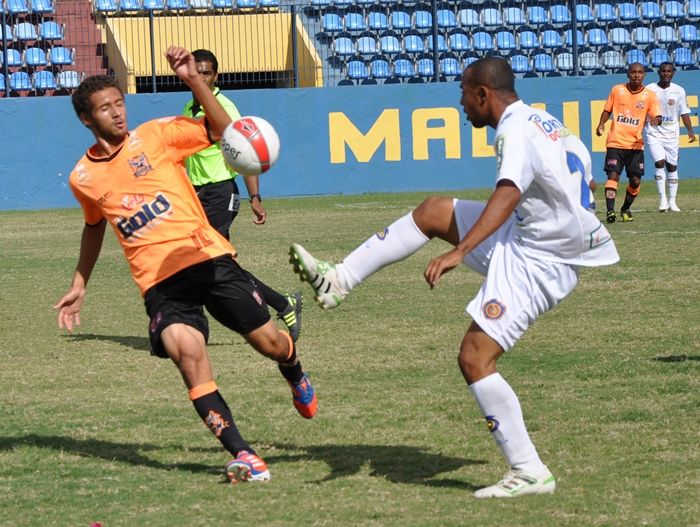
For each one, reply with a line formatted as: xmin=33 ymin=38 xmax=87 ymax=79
xmin=644 ymin=62 xmax=695 ymax=212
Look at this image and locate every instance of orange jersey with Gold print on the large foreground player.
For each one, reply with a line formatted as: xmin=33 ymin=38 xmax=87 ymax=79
xmin=69 ymin=117 xmax=235 ymax=294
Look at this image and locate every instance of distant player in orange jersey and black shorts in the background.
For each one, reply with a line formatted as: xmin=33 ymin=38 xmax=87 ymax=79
xmin=596 ymin=62 xmax=661 ymax=223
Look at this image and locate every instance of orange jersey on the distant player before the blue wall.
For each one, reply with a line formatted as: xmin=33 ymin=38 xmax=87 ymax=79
xmin=604 ymin=84 xmax=661 ymax=150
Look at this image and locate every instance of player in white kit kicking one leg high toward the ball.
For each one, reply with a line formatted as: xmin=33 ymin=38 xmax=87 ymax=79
xmin=290 ymin=57 xmax=619 ymax=498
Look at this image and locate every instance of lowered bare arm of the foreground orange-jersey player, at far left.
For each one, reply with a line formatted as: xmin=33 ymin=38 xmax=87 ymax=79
xmin=53 ymin=220 xmax=107 ymax=332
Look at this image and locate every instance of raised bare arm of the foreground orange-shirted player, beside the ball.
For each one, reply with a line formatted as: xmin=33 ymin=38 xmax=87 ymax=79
xmin=165 ymin=46 xmax=231 ymax=141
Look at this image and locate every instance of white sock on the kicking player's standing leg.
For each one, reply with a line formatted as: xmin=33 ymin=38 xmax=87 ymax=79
xmin=469 ymin=373 xmax=544 ymax=473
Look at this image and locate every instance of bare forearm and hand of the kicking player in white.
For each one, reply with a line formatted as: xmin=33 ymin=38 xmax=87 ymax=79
xmin=423 ymin=179 xmax=521 ymax=289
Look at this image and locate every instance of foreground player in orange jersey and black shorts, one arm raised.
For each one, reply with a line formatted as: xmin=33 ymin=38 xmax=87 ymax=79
xmin=54 ymin=47 xmax=317 ymax=483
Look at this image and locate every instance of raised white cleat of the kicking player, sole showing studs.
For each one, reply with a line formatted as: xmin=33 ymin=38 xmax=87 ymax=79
xmin=289 ymin=243 xmax=348 ymax=309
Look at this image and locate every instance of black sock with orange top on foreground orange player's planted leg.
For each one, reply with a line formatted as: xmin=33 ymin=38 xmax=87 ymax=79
xmin=190 ymin=381 xmax=255 ymax=457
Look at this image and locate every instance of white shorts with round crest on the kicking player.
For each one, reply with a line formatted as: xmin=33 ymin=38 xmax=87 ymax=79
xmin=454 ymin=200 xmax=578 ymax=351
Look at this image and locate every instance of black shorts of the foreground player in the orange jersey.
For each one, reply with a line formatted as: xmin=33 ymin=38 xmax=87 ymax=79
xmin=144 ymin=255 xmax=270 ymax=358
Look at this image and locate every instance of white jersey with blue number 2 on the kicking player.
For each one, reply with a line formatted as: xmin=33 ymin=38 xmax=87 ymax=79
xmin=495 ymin=101 xmax=620 ymax=266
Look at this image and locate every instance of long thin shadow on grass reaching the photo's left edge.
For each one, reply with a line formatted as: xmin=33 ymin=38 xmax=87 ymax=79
xmin=0 ymin=434 xmax=221 ymax=474
